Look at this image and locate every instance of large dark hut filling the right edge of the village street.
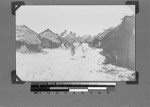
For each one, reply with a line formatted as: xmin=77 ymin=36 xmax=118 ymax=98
xmin=100 ymin=15 xmax=135 ymax=70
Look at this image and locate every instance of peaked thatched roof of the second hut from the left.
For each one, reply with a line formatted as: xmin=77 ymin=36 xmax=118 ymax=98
xmin=39 ymin=29 xmax=60 ymax=43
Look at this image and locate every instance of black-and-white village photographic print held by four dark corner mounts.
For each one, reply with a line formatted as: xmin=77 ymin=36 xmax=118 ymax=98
xmin=16 ymin=5 xmax=135 ymax=81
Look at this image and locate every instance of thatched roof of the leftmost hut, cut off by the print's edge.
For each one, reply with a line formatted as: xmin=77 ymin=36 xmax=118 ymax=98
xmin=16 ymin=25 xmax=41 ymax=45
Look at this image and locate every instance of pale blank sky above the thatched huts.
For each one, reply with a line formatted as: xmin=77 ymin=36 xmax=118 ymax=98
xmin=16 ymin=5 xmax=135 ymax=36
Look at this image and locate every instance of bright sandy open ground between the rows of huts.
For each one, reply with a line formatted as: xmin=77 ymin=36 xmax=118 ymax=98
xmin=16 ymin=47 xmax=135 ymax=81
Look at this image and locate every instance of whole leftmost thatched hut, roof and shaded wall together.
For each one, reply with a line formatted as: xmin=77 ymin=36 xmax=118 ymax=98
xmin=16 ymin=25 xmax=42 ymax=53
